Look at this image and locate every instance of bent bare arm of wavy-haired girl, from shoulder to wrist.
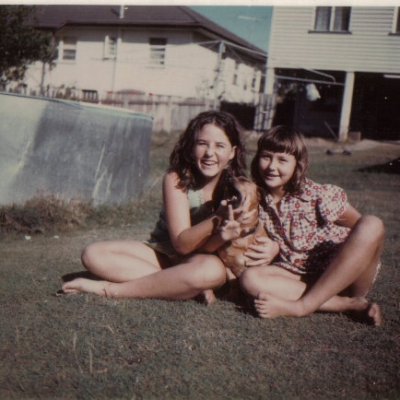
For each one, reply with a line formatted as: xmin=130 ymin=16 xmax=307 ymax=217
xmin=163 ymin=172 xmax=220 ymax=254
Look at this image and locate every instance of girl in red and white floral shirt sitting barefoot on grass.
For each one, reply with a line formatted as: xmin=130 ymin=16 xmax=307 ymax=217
xmin=240 ymin=126 xmax=384 ymax=325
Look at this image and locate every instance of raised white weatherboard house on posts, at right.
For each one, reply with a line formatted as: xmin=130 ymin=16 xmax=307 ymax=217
xmin=266 ymin=6 xmax=400 ymax=140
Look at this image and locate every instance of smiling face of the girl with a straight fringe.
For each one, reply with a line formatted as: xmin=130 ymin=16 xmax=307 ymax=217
xmin=258 ymin=150 xmax=297 ymax=199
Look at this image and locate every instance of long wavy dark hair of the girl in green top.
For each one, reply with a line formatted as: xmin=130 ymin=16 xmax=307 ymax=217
xmin=167 ymin=111 xmax=246 ymax=189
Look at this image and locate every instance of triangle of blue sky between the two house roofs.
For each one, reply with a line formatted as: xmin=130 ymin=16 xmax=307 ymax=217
xmin=191 ymin=6 xmax=272 ymax=51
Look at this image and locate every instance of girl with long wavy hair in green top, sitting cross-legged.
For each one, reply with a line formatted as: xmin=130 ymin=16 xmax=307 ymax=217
xmin=63 ymin=111 xmax=245 ymax=303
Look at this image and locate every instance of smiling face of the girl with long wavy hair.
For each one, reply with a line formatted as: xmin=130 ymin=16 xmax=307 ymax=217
xmin=193 ymin=124 xmax=235 ymax=178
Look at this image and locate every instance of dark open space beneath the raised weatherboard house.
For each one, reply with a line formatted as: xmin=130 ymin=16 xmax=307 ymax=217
xmin=271 ymin=69 xmax=400 ymax=140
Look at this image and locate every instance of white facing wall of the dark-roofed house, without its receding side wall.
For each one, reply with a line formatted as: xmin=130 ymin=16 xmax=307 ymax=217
xmin=36 ymin=27 xmax=217 ymax=96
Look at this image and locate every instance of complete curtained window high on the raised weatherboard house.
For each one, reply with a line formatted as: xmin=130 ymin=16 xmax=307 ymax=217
xmin=314 ymin=7 xmax=351 ymax=32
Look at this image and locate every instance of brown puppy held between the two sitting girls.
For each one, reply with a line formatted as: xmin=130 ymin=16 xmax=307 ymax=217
xmin=218 ymin=177 xmax=268 ymax=278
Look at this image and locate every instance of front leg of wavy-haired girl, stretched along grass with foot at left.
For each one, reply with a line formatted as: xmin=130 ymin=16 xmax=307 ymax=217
xmin=63 ymin=254 xmax=226 ymax=300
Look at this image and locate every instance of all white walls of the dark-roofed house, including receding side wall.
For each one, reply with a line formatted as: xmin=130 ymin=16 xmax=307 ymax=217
xmin=27 ymin=27 xmax=261 ymax=102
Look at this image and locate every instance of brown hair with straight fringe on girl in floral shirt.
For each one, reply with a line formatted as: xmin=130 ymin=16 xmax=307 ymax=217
xmin=251 ymin=125 xmax=308 ymax=194
